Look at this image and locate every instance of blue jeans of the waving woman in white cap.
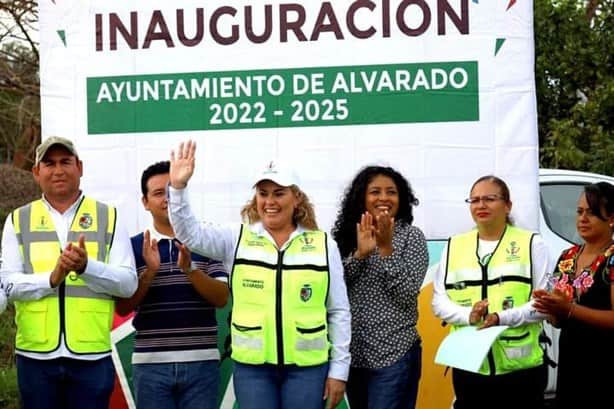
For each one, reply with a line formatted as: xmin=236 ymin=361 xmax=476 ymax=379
xmin=233 ymin=361 xmax=328 ymax=409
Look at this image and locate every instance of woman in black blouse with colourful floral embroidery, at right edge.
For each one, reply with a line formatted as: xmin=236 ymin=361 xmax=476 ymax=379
xmin=534 ymin=182 xmax=614 ymax=409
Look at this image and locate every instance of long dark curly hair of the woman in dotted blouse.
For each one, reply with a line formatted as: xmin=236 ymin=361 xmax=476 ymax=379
xmin=332 ymin=166 xmax=418 ymax=257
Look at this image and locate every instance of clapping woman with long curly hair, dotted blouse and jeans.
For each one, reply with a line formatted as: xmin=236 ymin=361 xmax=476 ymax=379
xmin=332 ymin=166 xmax=428 ymax=409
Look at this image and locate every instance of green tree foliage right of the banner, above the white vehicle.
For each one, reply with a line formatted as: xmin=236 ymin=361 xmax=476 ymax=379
xmin=534 ymin=0 xmax=614 ymax=175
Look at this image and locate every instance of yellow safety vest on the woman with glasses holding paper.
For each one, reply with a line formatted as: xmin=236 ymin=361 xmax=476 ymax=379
xmin=445 ymin=226 xmax=543 ymax=375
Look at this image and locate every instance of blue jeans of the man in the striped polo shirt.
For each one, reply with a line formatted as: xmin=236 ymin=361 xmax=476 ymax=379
xmin=132 ymin=360 xmax=220 ymax=409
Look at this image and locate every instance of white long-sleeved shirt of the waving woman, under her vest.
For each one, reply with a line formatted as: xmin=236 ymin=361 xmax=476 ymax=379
xmin=169 ymin=186 xmax=351 ymax=381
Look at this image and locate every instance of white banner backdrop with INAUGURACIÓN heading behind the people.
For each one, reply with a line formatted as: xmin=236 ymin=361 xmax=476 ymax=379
xmin=40 ymin=0 xmax=538 ymax=239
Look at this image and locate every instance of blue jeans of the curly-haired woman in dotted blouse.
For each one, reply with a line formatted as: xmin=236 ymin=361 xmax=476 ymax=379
xmin=347 ymin=340 xmax=422 ymax=409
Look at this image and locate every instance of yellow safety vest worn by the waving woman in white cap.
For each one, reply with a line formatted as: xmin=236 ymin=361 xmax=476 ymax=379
xmin=230 ymin=225 xmax=330 ymax=366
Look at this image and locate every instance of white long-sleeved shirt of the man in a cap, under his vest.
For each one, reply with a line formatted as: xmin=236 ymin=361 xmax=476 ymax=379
xmin=0 ymin=194 xmax=138 ymax=360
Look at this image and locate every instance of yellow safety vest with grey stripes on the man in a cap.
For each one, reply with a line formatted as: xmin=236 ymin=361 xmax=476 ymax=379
xmin=12 ymin=198 xmax=116 ymax=354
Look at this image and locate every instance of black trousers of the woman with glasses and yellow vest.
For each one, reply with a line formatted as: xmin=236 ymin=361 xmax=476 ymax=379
xmin=452 ymin=365 xmax=547 ymax=409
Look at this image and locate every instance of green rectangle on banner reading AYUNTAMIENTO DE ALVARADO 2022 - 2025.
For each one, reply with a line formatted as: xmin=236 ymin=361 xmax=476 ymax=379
xmin=87 ymin=61 xmax=479 ymax=134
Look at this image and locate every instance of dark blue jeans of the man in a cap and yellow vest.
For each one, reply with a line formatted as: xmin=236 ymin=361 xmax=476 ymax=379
xmin=17 ymin=355 xmax=115 ymax=409
